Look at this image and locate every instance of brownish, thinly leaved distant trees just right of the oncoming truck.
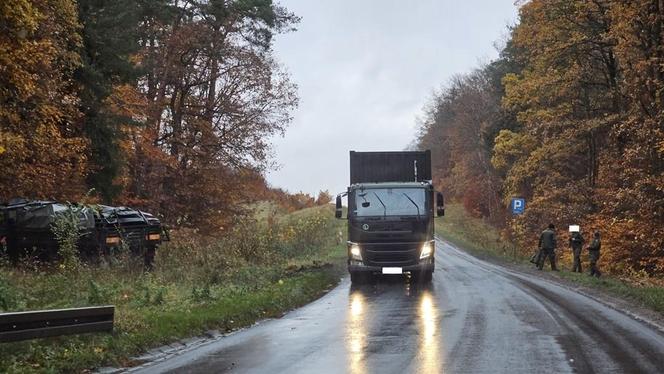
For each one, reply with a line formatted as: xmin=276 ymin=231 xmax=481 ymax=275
xmin=417 ymin=60 xmax=514 ymax=224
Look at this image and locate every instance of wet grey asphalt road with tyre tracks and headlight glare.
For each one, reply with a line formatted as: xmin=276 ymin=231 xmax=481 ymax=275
xmin=136 ymin=241 xmax=664 ymax=374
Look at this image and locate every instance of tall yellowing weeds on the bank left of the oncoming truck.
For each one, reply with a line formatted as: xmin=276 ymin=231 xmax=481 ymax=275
xmin=154 ymin=206 xmax=339 ymax=284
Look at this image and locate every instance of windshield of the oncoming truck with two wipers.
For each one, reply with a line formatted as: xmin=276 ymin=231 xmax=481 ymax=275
xmin=353 ymin=188 xmax=426 ymax=217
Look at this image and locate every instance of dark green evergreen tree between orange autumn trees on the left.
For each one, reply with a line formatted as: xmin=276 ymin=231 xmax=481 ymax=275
xmin=75 ymin=0 xmax=149 ymax=202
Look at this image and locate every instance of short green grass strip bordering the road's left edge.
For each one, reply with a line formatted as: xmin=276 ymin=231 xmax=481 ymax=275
xmin=0 ymin=268 xmax=339 ymax=372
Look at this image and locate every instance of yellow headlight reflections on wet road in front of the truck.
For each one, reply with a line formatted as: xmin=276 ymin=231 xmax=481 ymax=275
xmin=345 ymin=279 xmax=443 ymax=374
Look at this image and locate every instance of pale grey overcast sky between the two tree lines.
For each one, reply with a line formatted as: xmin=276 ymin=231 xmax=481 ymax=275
xmin=268 ymin=0 xmax=517 ymax=194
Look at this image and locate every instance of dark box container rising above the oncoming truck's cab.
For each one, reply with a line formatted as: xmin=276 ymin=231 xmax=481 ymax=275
xmin=350 ymin=151 xmax=431 ymax=184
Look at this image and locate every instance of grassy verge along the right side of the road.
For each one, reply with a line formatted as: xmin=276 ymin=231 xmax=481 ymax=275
xmin=436 ymin=204 xmax=664 ymax=313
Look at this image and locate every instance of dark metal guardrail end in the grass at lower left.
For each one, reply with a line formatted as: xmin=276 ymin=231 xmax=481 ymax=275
xmin=0 ymin=305 xmax=115 ymax=343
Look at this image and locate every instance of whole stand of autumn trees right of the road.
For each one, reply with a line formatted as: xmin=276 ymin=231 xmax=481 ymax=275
xmin=418 ymin=0 xmax=664 ymax=275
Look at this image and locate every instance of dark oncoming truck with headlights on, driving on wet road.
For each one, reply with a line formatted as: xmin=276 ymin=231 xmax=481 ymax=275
xmin=336 ymin=151 xmax=445 ymax=283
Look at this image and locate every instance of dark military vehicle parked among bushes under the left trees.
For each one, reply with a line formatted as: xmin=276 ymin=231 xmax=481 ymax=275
xmin=0 ymin=199 xmax=167 ymax=267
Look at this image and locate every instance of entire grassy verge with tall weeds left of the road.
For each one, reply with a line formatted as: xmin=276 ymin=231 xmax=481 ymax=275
xmin=0 ymin=207 xmax=345 ymax=373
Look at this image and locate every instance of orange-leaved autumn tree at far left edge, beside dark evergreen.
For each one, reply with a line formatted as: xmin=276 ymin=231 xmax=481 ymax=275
xmin=0 ymin=0 xmax=87 ymax=200
